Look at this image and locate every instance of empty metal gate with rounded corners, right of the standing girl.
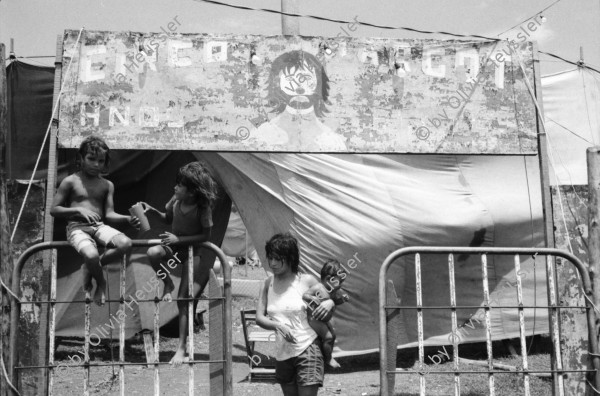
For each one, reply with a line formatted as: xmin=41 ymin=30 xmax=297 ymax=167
xmin=379 ymin=246 xmax=600 ymax=395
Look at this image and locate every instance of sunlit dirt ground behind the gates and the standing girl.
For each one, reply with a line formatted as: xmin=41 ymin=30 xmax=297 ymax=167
xmin=45 ymin=266 xmax=551 ymax=396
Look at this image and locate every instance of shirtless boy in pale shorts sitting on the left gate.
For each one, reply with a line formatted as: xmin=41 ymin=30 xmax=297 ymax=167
xmin=50 ymin=136 xmax=139 ymax=305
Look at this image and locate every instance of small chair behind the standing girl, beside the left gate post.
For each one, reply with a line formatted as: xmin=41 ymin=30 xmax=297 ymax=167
xmin=240 ymin=309 xmax=275 ymax=382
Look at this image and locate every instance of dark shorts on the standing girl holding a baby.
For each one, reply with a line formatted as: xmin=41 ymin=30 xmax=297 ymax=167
xmin=275 ymin=339 xmax=325 ymax=386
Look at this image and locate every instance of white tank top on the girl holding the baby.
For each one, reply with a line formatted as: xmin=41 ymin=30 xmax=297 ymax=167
xmin=267 ymin=274 xmax=317 ymax=361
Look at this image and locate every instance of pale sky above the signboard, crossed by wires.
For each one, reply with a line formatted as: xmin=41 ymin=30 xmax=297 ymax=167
xmin=0 ymin=0 xmax=600 ymax=75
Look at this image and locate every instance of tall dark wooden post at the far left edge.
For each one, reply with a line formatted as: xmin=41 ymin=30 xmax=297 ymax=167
xmin=0 ymin=44 xmax=14 ymax=396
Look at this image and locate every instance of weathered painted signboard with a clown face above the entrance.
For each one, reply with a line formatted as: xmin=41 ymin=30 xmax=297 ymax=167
xmin=59 ymin=31 xmax=536 ymax=154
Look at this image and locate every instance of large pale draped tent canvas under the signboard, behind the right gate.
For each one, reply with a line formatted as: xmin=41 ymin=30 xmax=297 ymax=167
xmin=201 ymin=153 xmax=548 ymax=355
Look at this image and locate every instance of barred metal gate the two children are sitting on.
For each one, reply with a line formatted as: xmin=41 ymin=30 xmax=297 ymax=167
xmin=9 ymin=236 xmax=233 ymax=396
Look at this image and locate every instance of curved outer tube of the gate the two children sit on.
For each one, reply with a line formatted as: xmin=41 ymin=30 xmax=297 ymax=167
xmin=9 ymin=235 xmax=233 ymax=396
